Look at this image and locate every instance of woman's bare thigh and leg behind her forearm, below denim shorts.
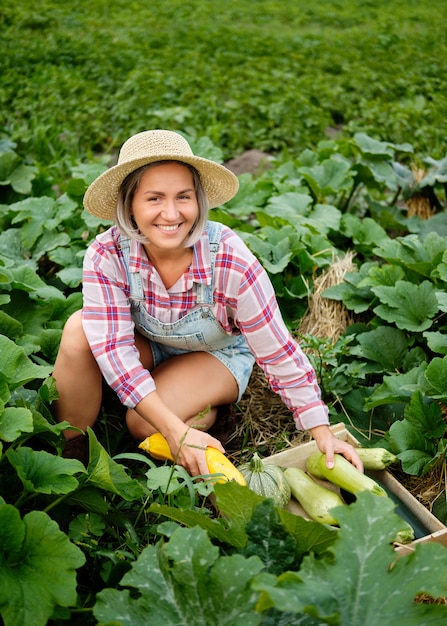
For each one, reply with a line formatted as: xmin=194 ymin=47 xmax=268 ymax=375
xmin=126 ymin=352 xmax=238 ymax=440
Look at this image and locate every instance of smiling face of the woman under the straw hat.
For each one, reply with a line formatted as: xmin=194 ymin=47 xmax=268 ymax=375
xmin=132 ymin=163 xmax=199 ymax=250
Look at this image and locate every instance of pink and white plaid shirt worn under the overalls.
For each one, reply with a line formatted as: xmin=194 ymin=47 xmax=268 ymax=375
xmin=83 ymin=226 xmax=328 ymax=429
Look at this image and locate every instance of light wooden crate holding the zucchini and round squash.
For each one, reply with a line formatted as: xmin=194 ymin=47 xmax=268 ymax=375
xmin=263 ymin=423 xmax=447 ymax=550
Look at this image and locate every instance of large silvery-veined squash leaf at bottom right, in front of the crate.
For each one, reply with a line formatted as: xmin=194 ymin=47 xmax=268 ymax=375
xmin=255 ymin=492 xmax=447 ymax=626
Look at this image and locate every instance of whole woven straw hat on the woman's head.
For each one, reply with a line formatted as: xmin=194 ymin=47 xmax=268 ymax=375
xmin=84 ymin=130 xmax=239 ymax=219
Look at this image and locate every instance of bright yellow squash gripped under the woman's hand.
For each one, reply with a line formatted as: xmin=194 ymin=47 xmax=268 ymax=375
xmin=138 ymin=433 xmax=247 ymax=485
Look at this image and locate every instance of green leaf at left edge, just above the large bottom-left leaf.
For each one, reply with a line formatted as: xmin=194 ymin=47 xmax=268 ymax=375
xmin=6 ymin=446 xmax=85 ymax=495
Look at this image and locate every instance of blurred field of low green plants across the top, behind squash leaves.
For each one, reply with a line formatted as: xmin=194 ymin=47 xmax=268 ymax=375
xmin=0 ymin=0 xmax=447 ymax=168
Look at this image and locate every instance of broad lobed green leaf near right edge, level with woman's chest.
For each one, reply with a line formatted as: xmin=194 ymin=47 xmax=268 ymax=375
xmin=371 ymin=280 xmax=439 ymax=332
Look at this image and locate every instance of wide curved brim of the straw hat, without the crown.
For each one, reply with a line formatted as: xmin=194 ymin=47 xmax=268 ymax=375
xmin=84 ymin=154 xmax=239 ymax=220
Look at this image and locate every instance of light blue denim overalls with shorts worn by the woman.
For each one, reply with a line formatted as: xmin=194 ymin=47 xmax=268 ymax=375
xmin=120 ymin=222 xmax=255 ymax=400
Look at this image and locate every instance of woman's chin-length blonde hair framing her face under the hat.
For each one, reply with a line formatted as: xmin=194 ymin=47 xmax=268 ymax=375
xmin=115 ymin=160 xmax=209 ymax=248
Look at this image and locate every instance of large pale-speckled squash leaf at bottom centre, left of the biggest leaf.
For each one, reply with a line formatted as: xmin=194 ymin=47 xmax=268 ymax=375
xmin=93 ymin=527 xmax=262 ymax=626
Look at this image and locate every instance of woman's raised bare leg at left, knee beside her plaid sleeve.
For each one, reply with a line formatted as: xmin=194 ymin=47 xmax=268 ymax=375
xmin=53 ymin=311 xmax=102 ymax=439
